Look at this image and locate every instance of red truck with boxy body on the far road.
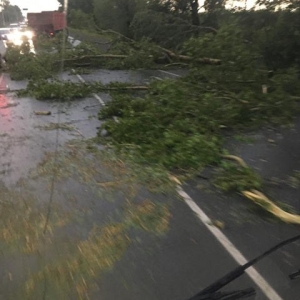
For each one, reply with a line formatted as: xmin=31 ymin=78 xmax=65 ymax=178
xmin=27 ymin=11 xmax=67 ymax=36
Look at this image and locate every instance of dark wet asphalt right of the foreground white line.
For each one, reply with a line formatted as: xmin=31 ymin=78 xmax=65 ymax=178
xmin=185 ymin=119 xmax=300 ymax=300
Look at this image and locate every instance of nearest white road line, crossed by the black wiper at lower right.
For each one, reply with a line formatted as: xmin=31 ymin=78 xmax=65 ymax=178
xmin=177 ymin=186 xmax=283 ymax=300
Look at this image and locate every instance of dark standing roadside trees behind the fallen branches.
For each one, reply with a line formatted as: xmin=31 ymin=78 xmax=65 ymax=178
xmin=59 ymin=0 xmax=300 ymax=72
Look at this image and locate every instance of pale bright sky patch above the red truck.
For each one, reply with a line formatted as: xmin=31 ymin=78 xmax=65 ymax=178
xmin=10 ymin=0 xmax=59 ymax=14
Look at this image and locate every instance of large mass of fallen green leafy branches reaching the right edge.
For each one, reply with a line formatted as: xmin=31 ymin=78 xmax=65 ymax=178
xmin=100 ymin=24 xmax=300 ymax=172
